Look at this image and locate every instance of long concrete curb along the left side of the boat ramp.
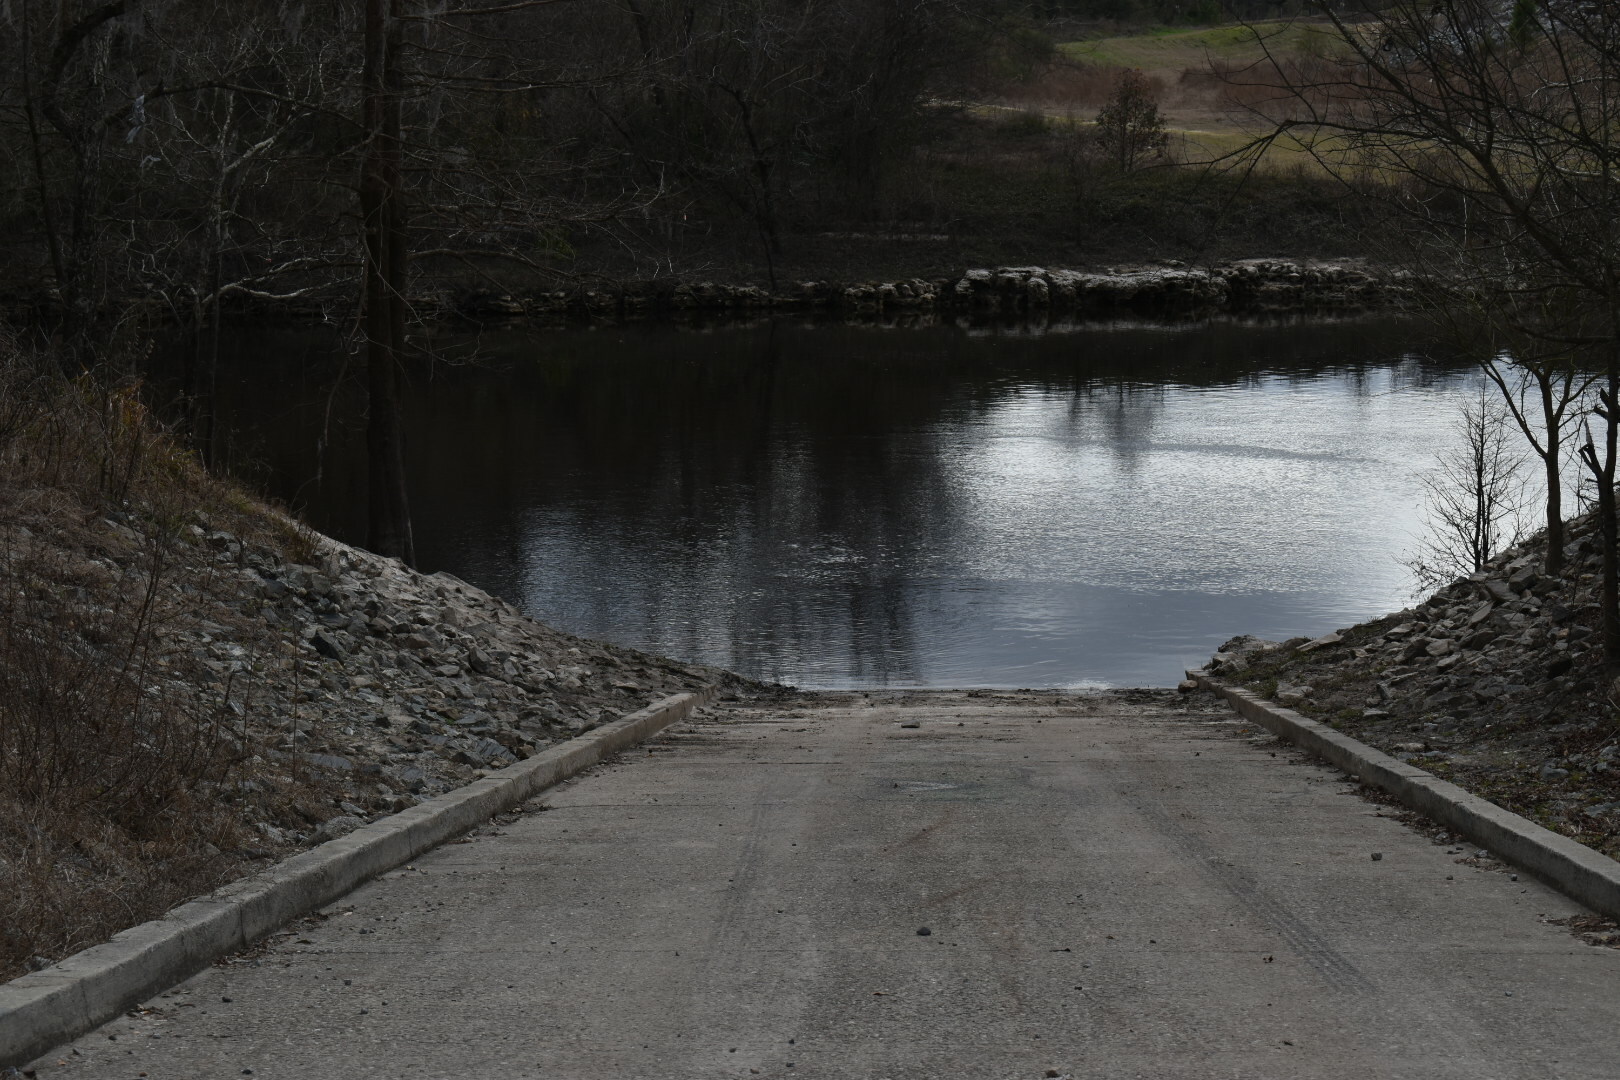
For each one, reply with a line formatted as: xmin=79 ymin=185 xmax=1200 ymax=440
xmin=0 ymin=687 xmax=716 ymax=1069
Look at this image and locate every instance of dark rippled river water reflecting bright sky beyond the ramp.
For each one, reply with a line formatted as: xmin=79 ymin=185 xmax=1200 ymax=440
xmin=205 ymin=319 xmax=1474 ymax=687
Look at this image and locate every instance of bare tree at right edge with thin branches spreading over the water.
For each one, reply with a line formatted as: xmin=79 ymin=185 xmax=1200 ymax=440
xmin=1238 ymin=0 xmax=1620 ymax=667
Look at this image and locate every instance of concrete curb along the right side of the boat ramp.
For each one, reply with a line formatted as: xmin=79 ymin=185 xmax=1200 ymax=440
xmin=1187 ymin=670 xmax=1620 ymax=918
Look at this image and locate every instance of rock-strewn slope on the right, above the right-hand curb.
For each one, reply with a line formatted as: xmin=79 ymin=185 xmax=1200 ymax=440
xmin=1205 ymin=520 xmax=1620 ymax=857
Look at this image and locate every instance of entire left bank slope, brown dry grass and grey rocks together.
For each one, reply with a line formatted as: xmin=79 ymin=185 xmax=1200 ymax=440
xmin=0 ymin=458 xmax=748 ymax=978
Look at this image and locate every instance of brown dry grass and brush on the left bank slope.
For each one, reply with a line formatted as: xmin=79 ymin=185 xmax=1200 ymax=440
xmin=0 ymin=340 xmax=328 ymax=978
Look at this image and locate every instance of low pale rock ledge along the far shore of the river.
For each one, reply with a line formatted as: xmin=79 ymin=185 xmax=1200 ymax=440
xmin=442 ymin=259 xmax=1411 ymax=321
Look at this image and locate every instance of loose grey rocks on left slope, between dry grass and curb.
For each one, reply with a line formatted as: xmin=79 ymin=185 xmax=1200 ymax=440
xmin=186 ymin=526 xmax=742 ymax=850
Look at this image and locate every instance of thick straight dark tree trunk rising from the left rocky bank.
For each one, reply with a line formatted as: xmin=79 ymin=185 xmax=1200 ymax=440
xmin=360 ymin=0 xmax=416 ymax=565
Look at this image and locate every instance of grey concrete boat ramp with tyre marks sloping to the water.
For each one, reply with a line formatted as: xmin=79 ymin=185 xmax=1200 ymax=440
xmin=29 ymin=691 xmax=1620 ymax=1080
